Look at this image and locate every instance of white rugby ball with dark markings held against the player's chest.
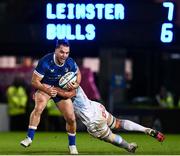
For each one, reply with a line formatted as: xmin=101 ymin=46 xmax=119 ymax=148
xmin=59 ymin=72 xmax=77 ymax=89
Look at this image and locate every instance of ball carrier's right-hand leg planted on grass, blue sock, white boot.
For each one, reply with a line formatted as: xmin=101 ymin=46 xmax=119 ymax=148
xmin=57 ymin=99 xmax=78 ymax=154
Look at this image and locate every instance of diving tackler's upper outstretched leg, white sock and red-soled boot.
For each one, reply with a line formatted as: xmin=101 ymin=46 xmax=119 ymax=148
xmin=107 ymin=113 xmax=165 ymax=142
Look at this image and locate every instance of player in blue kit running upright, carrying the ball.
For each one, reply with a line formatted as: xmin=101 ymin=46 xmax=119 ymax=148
xmin=20 ymin=39 xmax=81 ymax=154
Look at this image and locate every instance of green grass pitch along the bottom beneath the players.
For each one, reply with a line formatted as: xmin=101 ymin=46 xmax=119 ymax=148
xmin=0 ymin=132 xmax=180 ymax=155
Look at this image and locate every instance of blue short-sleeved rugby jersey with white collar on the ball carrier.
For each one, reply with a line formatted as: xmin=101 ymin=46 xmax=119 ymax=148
xmin=34 ymin=53 xmax=78 ymax=87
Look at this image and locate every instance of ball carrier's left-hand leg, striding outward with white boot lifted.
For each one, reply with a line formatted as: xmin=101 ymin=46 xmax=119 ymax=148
xmin=20 ymin=91 xmax=50 ymax=147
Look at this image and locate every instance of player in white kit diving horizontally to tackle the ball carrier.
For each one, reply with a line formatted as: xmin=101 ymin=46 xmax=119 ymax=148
xmin=56 ymin=86 xmax=165 ymax=153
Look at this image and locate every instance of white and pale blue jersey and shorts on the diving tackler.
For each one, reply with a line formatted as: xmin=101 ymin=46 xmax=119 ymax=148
xmin=73 ymin=87 xmax=110 ymax=138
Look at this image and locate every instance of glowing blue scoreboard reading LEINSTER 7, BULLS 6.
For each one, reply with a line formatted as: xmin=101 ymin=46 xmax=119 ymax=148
xmin=44 ymin=0 xmax=176 ymax=44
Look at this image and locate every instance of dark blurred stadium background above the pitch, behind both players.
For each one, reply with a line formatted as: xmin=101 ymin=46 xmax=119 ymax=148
xmin=0 ymin=0 xmax=180 ymax=133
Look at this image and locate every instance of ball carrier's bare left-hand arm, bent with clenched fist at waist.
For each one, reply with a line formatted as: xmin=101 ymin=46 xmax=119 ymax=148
xmin=31 ymin=73 xmax=57 ymax=97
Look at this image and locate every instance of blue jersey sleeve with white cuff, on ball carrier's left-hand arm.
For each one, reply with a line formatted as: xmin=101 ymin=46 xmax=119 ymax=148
xmin=34 ymin=59 xmax=46 ymax=78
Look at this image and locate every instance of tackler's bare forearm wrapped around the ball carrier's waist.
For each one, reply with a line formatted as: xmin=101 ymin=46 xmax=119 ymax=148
xmin=54 ymin=87 xmax=76 ymax=99
